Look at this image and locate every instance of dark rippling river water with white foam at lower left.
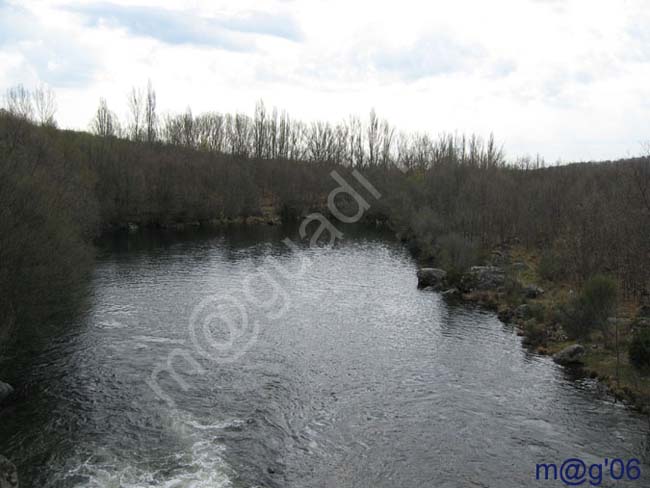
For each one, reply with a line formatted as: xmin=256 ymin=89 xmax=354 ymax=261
xmin=0 ymin=227 xmax=650 ymax=488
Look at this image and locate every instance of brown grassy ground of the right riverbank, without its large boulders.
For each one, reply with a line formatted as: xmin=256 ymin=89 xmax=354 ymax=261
xmin=432 ymin=246 xmax=650 ymax=414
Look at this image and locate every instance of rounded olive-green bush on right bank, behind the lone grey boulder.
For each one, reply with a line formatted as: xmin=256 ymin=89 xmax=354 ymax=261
xmin=562 ymin=275 xmax=618 ymax=339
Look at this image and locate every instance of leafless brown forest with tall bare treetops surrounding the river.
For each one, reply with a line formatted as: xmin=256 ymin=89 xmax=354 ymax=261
xmin=0 ymin=84 xmax=650 ymax=344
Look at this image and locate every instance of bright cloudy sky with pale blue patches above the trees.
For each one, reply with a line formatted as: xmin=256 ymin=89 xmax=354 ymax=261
xmin=0 ymin=0 xmax=650 ymax=161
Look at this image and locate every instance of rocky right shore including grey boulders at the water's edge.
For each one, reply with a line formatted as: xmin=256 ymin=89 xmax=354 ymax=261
xmin=417 ymin=248 xmax=650 ymax=413
